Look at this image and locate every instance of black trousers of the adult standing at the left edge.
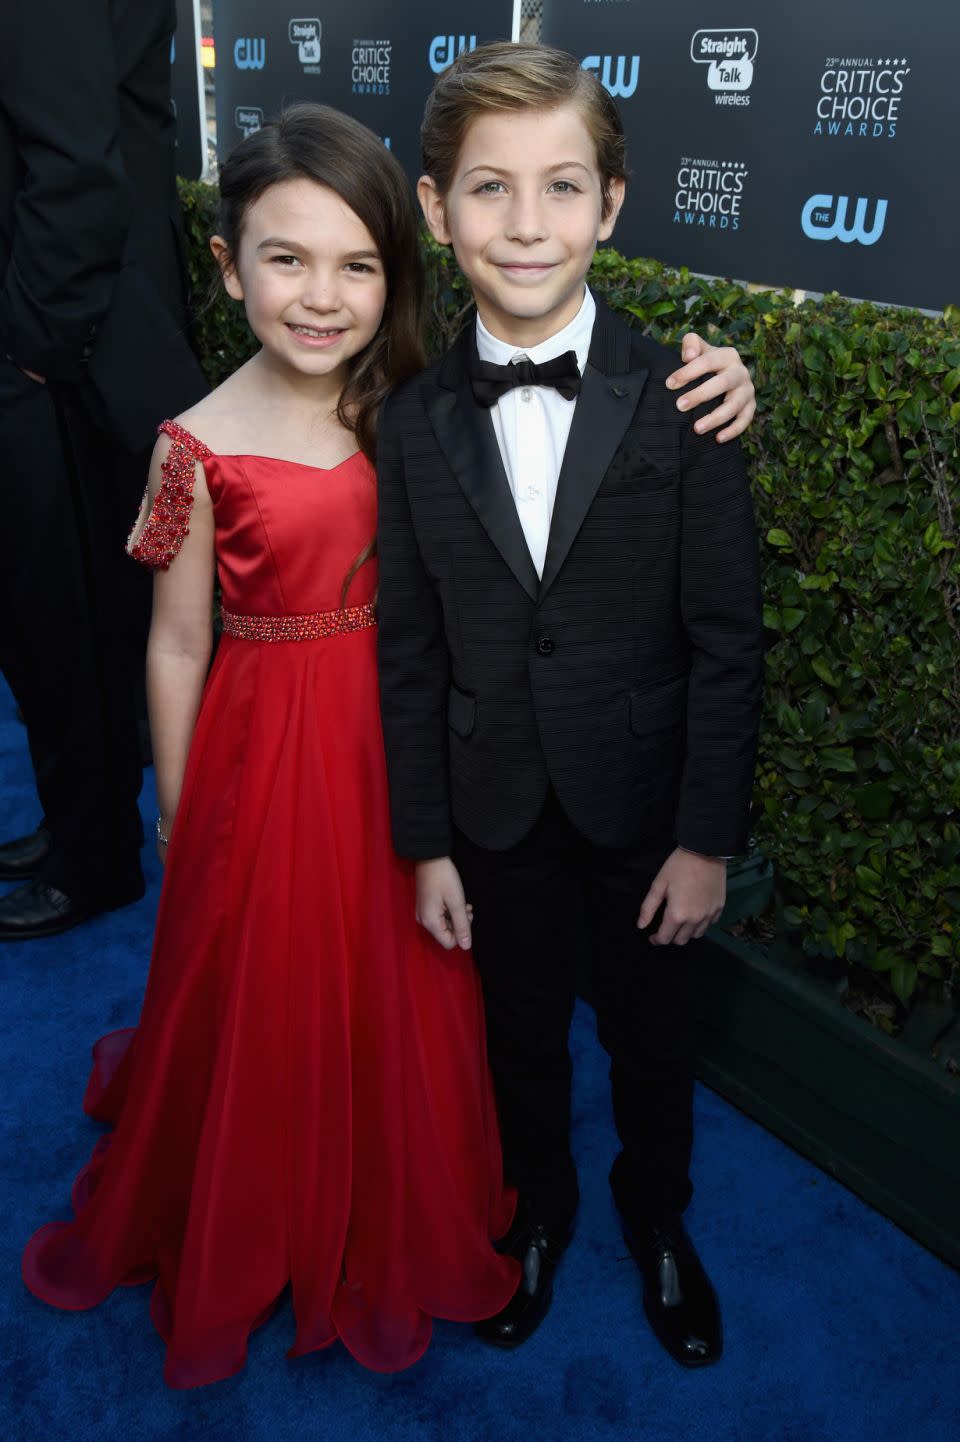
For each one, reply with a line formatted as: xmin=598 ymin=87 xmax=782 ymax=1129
xmin=0 ymin=361 xmax=148 ymax=904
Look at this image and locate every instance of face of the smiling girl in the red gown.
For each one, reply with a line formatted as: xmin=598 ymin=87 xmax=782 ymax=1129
xmin=210 ymin=179 xmax=386 ymax=382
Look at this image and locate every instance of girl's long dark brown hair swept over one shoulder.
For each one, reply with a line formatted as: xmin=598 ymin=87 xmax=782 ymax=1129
xmin=221 ymin=101 xmax=425 ymax=604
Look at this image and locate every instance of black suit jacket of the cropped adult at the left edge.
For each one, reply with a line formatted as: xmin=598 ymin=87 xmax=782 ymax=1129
xmin=0 ymin=0 xmax=206 ymax=450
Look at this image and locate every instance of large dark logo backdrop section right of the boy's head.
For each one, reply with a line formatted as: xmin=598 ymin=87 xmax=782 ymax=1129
xmin=542 ymin=0 xmax=960 ymax=309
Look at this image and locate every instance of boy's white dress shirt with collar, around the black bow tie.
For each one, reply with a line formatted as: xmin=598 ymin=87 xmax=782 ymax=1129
xmin=477 ymin=290 xmax=597 ymax=577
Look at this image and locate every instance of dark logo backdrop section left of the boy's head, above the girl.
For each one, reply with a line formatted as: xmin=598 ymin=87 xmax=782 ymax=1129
xmin=213 ymin=0 xmax=513 ymax=179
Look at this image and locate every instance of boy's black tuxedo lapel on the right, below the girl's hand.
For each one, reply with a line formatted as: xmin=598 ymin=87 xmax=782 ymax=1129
xmin=539 ymin=301 xmax=649 ymax=600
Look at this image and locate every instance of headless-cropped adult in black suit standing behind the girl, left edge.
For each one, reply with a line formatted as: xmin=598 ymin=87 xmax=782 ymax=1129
xmin=0 ymin=0 xmax=206 ymax=940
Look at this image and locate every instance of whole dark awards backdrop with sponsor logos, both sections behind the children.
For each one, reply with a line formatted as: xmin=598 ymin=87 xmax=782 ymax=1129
xmin=200 ymin=0 xmax=960 ymax=310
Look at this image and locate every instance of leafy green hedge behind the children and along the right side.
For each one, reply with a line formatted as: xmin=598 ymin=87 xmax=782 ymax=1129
xmin=182 ymin=183 xmax=960 ymax=1004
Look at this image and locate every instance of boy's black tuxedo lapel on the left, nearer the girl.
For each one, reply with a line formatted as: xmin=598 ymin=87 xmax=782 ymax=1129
xmin=427 ymin=327 xmax=541 ymax=601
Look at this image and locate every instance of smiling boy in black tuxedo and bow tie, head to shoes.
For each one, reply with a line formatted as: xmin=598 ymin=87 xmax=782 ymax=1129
xmin=378 ymin=45 xmax=763 ymax=1366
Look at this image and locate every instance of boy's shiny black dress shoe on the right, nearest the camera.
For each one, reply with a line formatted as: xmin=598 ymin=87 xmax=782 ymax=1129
xmin=624 ymin=1217 xmax=724 ymax=1367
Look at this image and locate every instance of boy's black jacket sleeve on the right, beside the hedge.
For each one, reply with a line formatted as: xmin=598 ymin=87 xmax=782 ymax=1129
xmin=677 ymin=407 xmax=763 ymax=857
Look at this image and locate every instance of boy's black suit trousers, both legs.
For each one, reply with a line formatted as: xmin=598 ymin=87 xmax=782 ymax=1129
xmin=454 ymin=795 xmax=696 ymax=1233
